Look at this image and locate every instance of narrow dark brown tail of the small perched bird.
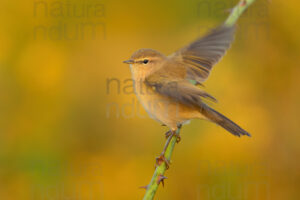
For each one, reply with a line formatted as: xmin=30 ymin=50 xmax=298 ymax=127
xmin=200 ymin=104 xmax=251 ymax=137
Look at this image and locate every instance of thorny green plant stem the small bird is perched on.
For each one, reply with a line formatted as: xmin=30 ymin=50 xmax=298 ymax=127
xmin=143 ymin=0 xmax=255 ymax=200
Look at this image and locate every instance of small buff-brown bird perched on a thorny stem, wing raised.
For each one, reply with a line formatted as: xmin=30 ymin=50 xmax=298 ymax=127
xmin=124 ymin=25 xmax=250 ymax=140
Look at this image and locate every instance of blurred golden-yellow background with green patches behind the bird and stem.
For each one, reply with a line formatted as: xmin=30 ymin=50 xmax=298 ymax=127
xmin=0 ymin=0 xmax=300 ymax=200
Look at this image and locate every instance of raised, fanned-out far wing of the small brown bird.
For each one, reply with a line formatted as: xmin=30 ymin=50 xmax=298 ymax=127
xmin=169 ymin=25 xmax=235 ymax=84
